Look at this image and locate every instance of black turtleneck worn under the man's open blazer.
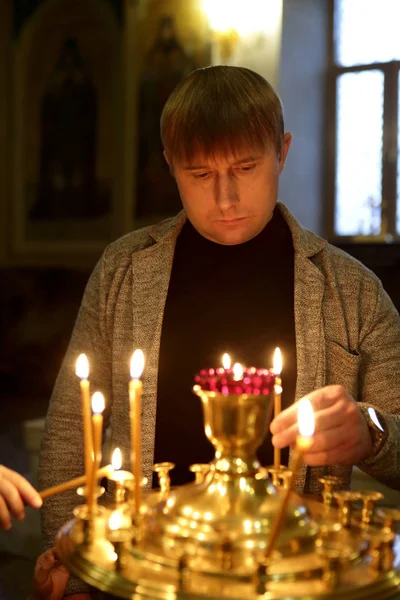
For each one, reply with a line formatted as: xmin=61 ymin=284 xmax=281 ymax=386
xmin=154 ymin=210 xmax=297 ymax=485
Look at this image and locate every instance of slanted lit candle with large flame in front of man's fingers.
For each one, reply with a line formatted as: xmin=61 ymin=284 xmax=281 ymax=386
xmin=264 ymin=398 xmax=315 ymax=560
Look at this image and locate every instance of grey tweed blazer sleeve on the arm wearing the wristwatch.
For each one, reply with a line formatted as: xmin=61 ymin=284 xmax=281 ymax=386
xmin=358 ymin=282 xmax=400 ymax=490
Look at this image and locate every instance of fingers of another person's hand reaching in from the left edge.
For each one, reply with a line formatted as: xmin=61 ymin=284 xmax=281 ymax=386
xmin=0 ymin=465 xmax=42 ymax=529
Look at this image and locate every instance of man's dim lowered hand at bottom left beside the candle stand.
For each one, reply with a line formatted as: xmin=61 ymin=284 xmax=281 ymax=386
xmin=33 ymin=548 xmax=69 ymax=600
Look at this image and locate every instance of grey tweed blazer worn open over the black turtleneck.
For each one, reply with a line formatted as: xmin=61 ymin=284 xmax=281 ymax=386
xmin=40 ymin=204 xmax=400 ymax=591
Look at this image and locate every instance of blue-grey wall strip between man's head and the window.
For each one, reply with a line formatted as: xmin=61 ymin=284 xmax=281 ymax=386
xmin=279 ymin=0 xmax=329 ymax=234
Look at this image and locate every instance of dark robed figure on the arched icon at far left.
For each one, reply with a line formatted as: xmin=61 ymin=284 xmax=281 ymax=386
xmin=30 ymin=38 xmax=110 ymax=219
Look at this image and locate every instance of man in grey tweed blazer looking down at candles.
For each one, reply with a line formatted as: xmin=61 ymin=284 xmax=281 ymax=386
xmin=41 ymin=66 xmax=400 ymax=593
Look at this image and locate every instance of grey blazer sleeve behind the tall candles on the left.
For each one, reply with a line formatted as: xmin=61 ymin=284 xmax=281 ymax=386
xmin=39 ymin=248 xmax=111 ymax=594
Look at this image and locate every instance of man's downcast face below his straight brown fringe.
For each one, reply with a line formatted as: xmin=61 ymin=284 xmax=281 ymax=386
xmin=166 ymin=133 xmax=291 ymax=245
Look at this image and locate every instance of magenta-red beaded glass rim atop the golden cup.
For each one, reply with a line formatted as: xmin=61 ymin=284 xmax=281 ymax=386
xmin=194 ymin=367 xmax=277 ymax=396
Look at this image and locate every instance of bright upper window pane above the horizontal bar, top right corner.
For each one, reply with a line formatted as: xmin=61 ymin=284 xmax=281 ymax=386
xmin=335 ymin=0 xmax=400 ymax=67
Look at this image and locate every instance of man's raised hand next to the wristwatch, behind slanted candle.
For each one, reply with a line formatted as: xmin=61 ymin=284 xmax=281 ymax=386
xmin=270 ymin=385 xmax=372 ymax=467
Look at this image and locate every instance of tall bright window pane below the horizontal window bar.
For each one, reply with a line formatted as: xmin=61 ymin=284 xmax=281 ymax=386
xmin=335 ymin=71 xmax=384 ymax=235
